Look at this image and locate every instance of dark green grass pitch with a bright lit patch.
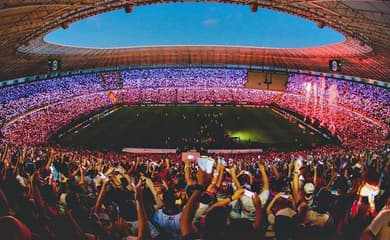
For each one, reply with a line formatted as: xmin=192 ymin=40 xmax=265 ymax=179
xmin=57 ymin=106 xmax=325 ymax=151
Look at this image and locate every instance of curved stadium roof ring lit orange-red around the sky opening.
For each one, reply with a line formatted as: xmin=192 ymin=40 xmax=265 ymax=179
xmin=0 ymin=0 xmax=390 ymax=81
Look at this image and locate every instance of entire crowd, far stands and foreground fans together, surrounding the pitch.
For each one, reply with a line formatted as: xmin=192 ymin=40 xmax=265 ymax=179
xmin=0 ymin=68 xmax=390 ymax=240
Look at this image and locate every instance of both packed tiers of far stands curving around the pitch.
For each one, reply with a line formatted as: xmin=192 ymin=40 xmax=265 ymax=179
xmin=0 ymin=68 xmax=390 ymax=146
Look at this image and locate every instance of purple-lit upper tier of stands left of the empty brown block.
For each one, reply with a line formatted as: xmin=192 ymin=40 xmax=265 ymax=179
xmin=0 ymin=68 xmax=247 ymax=125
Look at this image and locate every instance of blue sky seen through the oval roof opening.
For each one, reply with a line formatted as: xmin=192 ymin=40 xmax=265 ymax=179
xmin=45 ymin=3 xmax=344 ymax=48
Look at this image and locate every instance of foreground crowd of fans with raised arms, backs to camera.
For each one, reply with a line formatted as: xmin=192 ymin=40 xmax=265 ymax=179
xmin=0 ymin=145 xmax=390 ymax=240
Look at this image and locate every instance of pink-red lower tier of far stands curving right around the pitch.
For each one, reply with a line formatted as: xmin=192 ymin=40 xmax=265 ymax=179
xmin=2 ymin=87 xmax=389 ymax=147
